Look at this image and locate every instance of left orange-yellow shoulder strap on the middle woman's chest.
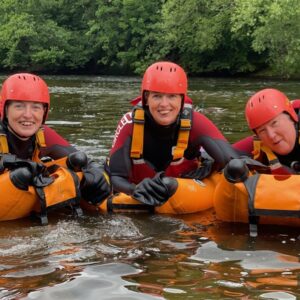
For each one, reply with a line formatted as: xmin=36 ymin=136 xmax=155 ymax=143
xmin=130 ymin=109 xmax=145 ymax=158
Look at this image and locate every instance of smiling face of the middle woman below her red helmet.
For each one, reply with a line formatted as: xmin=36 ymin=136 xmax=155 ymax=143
xmin=146 ymin=92 xmax=182 ymax=126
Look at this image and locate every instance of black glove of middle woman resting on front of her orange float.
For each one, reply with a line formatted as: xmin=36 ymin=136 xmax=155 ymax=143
xmin=132 ymin=172 xmax=178 ymax=206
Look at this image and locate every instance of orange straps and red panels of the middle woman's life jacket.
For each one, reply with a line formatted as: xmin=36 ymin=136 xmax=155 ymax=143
xmin=130 ymin=103 xmax=199 ymax=183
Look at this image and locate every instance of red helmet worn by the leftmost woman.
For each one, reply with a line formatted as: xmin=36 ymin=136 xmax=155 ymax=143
xmin=0 ymin=73 xmax=50 ymax=122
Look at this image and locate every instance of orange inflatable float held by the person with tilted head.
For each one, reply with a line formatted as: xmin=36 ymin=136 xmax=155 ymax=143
xmin=213 ymin=159 xmax=300 ymax=235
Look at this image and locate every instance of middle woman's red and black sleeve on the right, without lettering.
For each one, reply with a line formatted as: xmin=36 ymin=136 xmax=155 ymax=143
xmin=190 ymin=112 xmax=240 ymax=169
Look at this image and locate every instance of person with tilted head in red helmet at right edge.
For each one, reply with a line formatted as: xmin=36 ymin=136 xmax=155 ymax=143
xmin=234 ymin=88 xmax=300 ymax=173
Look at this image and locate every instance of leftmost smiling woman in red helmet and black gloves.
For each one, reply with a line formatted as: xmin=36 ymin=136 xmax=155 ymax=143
xmin=0 ymin=73 xmax=110 ymax=204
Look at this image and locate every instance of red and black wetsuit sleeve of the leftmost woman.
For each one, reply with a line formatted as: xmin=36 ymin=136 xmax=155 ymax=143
xmin=41 ymin=126 xmax=77 ymax=159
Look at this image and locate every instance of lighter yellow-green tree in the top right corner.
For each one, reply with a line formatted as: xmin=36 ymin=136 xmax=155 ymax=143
xmin=231 ymin=0 xmax=300 ymax=77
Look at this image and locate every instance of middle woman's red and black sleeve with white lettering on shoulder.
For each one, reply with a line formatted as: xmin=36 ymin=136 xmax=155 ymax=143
xmin=109 ymin=113 xmax=135 ymax=194
